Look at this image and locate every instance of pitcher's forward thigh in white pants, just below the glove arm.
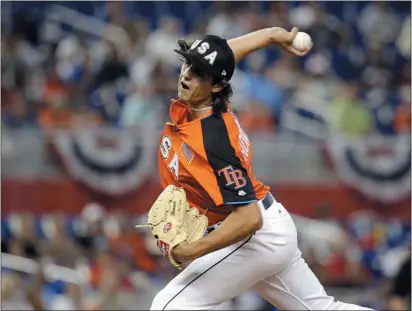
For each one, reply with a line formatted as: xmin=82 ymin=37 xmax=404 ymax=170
xmin=151 ymin=241 xmax=268 ymax=310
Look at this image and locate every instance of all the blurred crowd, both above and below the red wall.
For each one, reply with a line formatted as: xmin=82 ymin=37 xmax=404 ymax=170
xmin=1 ymin=1 xmax=411 ymax=310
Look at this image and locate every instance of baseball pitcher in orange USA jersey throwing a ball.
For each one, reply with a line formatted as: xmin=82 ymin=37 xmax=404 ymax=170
xmin=140 ymin=27 xmax=371 ymax=310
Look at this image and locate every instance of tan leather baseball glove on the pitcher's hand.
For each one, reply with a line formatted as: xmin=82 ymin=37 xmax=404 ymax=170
xmin=137 ymin=185 xmax=208 ymax=269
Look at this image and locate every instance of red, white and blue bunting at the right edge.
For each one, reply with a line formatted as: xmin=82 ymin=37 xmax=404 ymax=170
xmin=327 ymin=134 xmax=411 ymax=203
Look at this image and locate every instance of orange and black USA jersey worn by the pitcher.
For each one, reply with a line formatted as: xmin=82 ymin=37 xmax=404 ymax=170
xmin=158 ymin=100 xmax=269 ymax=225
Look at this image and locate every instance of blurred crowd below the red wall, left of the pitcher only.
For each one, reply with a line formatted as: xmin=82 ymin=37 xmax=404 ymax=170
xmin=2 ymin=203 xmax=166 ymax=310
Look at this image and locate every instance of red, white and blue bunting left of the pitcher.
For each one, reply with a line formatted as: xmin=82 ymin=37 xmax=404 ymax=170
xmin=52 ymin=129 xmax=157 ymax=195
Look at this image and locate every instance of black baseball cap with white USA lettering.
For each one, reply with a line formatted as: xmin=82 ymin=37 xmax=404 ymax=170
xmin=173 ymin=35 xmax=235 ymax=81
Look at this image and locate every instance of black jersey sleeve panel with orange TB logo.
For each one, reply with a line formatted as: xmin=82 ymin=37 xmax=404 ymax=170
xmin=201 ymin=115 xmax=257 ymax=206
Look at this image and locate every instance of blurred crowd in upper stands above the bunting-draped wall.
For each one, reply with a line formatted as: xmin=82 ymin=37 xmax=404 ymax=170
xmin=1 ymin=1 xmax=411 ymax=135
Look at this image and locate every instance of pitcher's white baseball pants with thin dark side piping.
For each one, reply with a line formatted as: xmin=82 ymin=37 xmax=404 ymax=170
xmin=151 ymin=194 xmax=372 ymax=310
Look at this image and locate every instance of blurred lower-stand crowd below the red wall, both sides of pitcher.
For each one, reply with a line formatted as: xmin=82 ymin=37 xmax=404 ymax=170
xmin=1 ymin=203 xmax=410 ymax=310
